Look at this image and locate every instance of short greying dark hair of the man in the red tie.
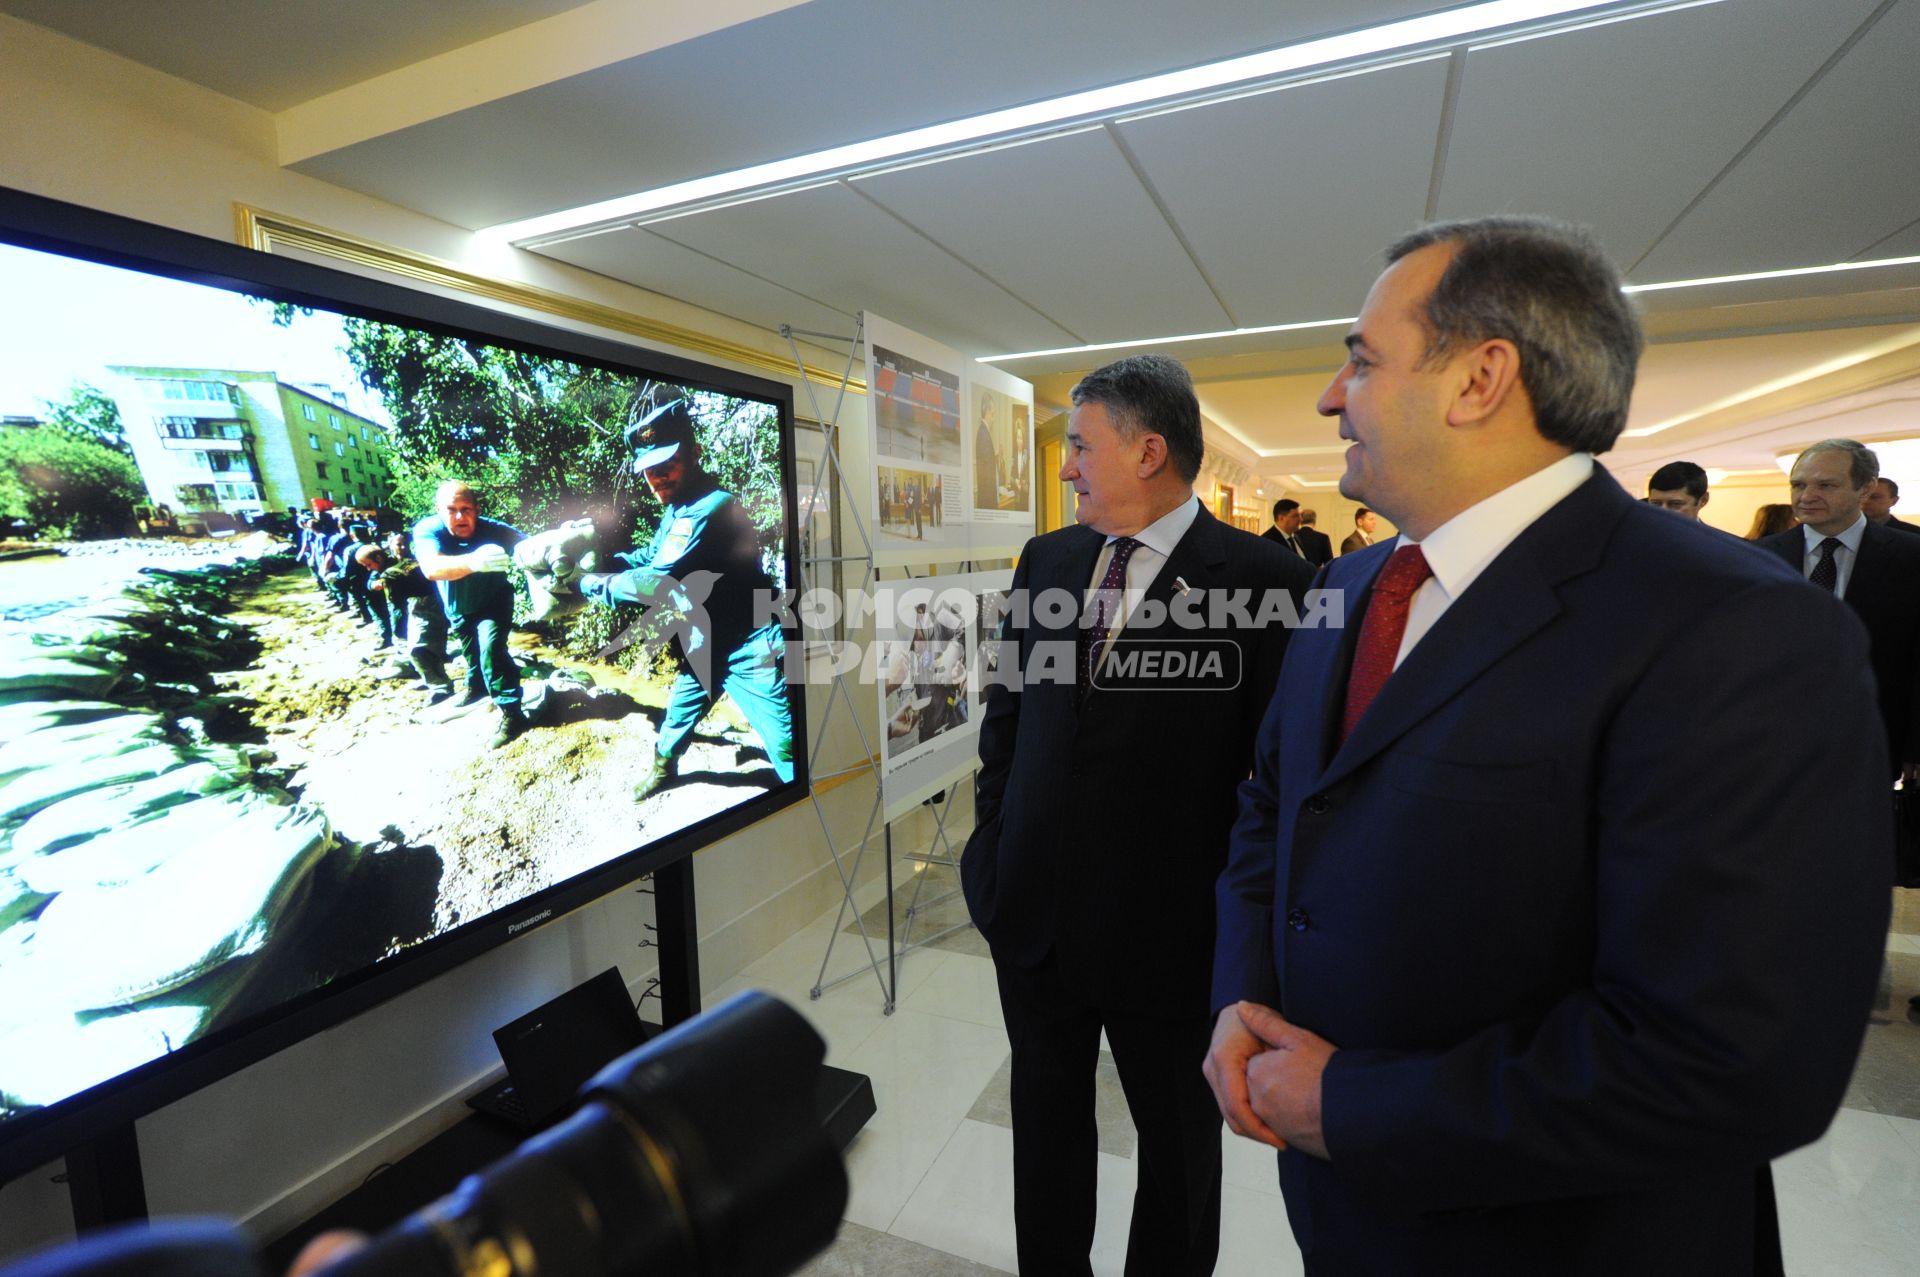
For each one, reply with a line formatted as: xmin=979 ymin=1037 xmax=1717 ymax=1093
xmin=1386 ymin=217 xmax=1645 ymax=453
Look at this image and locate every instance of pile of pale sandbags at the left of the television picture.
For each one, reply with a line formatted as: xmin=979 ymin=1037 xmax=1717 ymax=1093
xmin=0 ymin=555 xmax=336 ymax=1112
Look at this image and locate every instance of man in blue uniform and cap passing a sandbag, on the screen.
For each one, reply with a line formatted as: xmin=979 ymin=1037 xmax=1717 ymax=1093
xmin=578 ymin=399 xmax=793 ymax=801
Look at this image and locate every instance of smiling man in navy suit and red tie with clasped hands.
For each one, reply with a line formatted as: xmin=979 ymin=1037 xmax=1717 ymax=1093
xmin=1206 ymin=217 xmax=1889 ymax=1277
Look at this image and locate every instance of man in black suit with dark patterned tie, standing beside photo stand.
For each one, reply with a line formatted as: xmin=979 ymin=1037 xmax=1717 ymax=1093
xmin=960 ymin=355 xmax=1313 ymax=1277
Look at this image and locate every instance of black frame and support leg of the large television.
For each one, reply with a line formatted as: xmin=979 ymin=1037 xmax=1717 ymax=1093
xmin=0 ymin=186 xmax=810 ymax=1190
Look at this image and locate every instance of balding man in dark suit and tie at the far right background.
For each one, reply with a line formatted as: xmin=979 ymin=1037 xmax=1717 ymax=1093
xmin=1757 ymin=440 xmax=1920 ymax=783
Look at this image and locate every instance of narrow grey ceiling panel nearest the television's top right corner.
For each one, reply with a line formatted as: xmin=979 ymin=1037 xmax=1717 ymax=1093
xmin=541 ymin=227 xmax=852 ymax=336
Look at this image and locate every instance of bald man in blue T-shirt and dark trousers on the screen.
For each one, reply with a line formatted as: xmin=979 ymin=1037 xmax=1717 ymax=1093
xmin=413 ymin=478 xmax=526 ymax=749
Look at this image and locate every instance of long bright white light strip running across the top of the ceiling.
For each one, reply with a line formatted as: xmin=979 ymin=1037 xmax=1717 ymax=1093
xmin=480 ymin=0 xmax=1617 ymax=244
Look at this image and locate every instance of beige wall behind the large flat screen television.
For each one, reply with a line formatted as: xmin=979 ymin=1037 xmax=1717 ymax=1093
xmin=0 ymin=15 xmax=879 ymax=1260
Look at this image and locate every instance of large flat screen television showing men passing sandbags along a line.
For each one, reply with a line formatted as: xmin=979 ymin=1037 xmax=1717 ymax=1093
xmin=0 ymin=190 xmax=806 ymax=1181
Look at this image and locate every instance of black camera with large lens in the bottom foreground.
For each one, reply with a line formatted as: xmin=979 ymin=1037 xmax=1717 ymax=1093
xmin=0 ymin=993 xmax=847 ymax=1277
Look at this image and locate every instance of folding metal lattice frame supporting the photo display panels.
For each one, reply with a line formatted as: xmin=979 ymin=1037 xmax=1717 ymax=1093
xmin=780 ymin=313 xmax=977 ymax=1016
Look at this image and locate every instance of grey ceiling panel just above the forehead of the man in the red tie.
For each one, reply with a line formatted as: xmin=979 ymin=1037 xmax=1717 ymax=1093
xmin=1117 ymin=60 xmax=1446 ymax=326
